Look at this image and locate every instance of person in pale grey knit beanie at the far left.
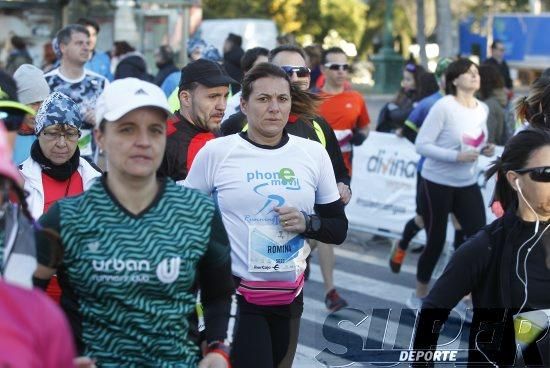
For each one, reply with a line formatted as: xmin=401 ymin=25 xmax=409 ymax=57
xmin=13 ymin=64 xmax=50 ymax=165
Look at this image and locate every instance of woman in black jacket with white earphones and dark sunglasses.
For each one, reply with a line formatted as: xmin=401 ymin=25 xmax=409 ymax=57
xmin=414 ymin=128 xmax=550 ymax=367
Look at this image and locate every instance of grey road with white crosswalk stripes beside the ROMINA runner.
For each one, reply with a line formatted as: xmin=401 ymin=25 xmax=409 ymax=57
xmin=293 ymin=233 xmax=467 ymax=368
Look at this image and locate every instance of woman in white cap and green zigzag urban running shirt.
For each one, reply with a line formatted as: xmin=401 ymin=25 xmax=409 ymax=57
xmin=32 ymin=78 xmax=234 ymax=368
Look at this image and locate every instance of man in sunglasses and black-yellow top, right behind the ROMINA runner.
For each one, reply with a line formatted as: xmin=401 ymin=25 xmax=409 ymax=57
xmin=269 ymin=45 xmax=351 ymax=311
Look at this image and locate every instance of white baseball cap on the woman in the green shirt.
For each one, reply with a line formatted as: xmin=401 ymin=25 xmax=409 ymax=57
xmin=95 ymin=78 xmax=171 ymax=127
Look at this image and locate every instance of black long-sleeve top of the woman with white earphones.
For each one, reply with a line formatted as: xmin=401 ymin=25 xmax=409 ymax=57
xmin=414 ymin=213 xmax=550 ymax=367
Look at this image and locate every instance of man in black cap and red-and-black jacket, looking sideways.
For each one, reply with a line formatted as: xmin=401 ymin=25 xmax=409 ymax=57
xmin=158 ymin=59 xmax=237 ymax=181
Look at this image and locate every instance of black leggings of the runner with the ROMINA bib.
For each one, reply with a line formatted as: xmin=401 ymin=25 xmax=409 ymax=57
xmin=231 ymin=292 xmax=304 ymax=368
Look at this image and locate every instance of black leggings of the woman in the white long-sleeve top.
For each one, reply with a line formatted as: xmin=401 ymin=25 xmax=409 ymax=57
xmin=416 ymin=178 xmax=486 ymax=284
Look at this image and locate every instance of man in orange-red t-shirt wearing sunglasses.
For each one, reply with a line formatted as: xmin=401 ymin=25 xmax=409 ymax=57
xmin=319 ymin=47 xmax=370 ymax=173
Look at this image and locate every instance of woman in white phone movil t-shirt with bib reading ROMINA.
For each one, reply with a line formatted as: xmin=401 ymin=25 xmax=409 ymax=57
xmin=184 ymin=63 xmax=347 ymax=367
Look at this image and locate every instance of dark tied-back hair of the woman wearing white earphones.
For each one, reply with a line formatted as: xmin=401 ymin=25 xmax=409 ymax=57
xmin=485 ymin=127 xmax=550 ymax=211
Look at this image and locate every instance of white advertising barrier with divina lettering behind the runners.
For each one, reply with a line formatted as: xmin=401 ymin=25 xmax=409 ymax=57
xmin=346 ymin=132 xmax=503 ymax=242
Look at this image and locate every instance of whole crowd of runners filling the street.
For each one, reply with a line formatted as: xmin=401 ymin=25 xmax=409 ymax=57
xmin=0 ymin=15 xmax=550 ymax=368
